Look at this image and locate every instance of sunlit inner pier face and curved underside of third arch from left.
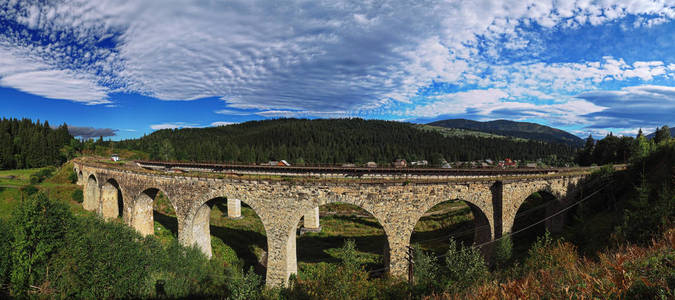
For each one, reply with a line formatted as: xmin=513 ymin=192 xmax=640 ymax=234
xmin=131 ymin=187 xmax=176 ymax=236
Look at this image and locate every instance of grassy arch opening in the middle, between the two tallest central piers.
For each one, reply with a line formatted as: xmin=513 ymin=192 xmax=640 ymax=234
xmin=296 ymin=202 xmax=389 ymax=279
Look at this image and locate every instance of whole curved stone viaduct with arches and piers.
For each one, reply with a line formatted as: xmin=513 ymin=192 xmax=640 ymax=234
xmin=74 ymin=159 xmax=589 ymax=286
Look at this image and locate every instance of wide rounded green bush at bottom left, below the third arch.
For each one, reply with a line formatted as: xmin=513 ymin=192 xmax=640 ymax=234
xmin=52 ymin=216 xmax=150 ymax=299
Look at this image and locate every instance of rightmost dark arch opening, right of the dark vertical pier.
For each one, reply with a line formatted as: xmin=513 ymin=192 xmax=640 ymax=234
xmin=511 ymin=190 xmax=558 ymax=255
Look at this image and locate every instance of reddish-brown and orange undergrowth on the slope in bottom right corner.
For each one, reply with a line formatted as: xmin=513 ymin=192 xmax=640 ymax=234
xmin=438 ymin=229 xmax=675 ymax=299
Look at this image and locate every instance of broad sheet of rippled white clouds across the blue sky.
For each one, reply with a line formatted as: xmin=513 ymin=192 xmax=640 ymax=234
xmin=0 ymin=0 xmax=675 ymax=120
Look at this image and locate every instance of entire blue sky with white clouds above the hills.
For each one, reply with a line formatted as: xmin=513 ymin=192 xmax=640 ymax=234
xmin=0 ymin=0 xmax=675 ymax=139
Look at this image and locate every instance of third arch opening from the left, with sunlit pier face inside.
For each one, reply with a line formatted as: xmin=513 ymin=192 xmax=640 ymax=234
xmin=131 ymin=187 xmax=178 ymax=237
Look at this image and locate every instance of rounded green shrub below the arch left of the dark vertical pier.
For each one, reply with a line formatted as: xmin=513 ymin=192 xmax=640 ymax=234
xmin=443 ymin=238 xmax=489 ymax=291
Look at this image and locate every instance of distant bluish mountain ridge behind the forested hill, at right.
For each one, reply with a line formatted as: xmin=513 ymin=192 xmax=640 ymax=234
xmin=427 ymin=119 xmax=584 ymax=146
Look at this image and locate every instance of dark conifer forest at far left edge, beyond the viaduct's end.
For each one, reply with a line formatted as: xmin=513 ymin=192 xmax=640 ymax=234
xmin=0 ymin=118 xmax=73 ymax=169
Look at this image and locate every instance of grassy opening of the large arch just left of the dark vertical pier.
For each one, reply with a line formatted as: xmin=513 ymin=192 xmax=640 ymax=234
xmin=410 ymin=199 xmax=493 ymax=254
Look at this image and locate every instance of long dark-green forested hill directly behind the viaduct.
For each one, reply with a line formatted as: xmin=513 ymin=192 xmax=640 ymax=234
xmin=118 ymin=119 xmax=575 ymax=164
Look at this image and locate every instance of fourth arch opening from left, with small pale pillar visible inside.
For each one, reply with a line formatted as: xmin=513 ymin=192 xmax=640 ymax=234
xmin=192 ymin=197 xmax=268 ymax=275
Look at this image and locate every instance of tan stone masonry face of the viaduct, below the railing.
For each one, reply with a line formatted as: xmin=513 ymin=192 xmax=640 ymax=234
xmin=75 ymin=162 xmax=578 ymax=286
